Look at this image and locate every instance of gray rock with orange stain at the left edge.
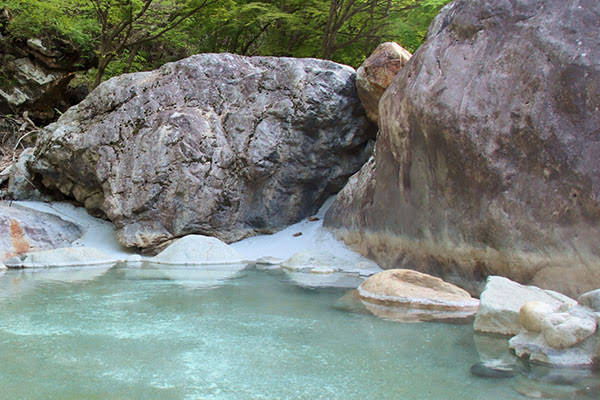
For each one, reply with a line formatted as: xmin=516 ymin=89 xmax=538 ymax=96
xmin=0 ymin=202 xmax=84 ymax=260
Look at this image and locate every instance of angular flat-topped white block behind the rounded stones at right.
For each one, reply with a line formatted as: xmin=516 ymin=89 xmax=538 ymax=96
xmin=474 ymin=276 xmax=576 ymax=335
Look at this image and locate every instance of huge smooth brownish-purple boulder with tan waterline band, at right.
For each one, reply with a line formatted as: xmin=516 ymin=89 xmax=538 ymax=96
xmin=325 ymin=0 xmax=600 ymax=297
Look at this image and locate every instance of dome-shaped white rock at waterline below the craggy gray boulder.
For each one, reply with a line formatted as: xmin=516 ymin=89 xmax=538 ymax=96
xmin=148 ymin=235 xmax=246 ymax=265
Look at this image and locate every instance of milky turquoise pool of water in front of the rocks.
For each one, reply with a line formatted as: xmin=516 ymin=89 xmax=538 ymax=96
xmin=0 ymin=267 xmax=600 ymax=400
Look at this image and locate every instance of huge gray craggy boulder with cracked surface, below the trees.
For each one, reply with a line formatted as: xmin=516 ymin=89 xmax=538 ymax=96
xmin=30 ymin=54 xmax=374 ymax=248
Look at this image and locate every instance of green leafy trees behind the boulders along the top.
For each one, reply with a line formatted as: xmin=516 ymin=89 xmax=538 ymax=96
xmin=4 ymin=0 xmax=450 ymax=83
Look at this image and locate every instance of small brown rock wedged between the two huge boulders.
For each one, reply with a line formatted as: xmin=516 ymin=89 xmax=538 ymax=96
xmin=356 ymin=42 xmax=412 ymax=123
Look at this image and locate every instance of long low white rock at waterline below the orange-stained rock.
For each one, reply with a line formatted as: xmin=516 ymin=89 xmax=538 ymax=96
xmin=4 ymin=247 xmax=117 ymax=268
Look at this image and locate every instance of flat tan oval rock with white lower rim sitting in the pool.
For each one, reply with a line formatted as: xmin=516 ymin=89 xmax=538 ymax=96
xmin=358 ymin=269 xmax=479 ymax=320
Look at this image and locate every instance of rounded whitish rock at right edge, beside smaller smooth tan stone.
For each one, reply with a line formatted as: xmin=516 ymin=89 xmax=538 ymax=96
xmin=542 ymin=313 xmax=596 ymax=349
